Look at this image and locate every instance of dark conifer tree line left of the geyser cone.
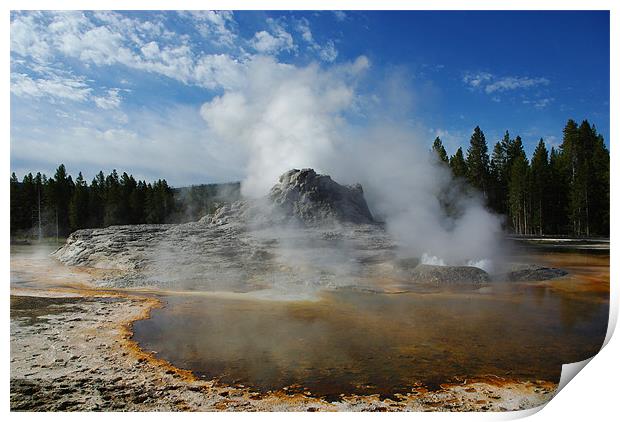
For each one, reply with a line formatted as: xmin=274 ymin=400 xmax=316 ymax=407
xmin=10 ymin=164 xmax=239 ymax=237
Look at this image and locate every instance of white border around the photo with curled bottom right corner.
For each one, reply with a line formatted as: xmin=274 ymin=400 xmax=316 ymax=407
xmin=0 ymin=0 xmax=620 ymax=421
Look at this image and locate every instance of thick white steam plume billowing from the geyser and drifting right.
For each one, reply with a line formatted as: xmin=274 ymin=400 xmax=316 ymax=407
xmin=201 ymin=56 xmax=501 ymax=270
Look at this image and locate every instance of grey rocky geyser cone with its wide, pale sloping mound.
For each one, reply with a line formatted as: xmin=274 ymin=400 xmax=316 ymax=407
xmin=55 ymin=169 xmax=568 ymax=299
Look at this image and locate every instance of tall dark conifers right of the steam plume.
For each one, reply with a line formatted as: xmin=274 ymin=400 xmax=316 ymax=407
xmin=432 ymin=119 xmax=610 ymax=236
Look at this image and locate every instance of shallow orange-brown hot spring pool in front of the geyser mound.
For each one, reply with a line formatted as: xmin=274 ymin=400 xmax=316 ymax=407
xmin=134 ymin=253 xmax=609 ymax=398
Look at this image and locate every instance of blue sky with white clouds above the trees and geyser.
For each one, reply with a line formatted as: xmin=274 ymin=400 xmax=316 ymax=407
xmin=11 ymin=11 xmax=609 ymax=185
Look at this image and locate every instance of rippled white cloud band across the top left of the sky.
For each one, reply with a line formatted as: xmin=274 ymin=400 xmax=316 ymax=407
xmin=11 ymin=11 xmax=338 ymax=94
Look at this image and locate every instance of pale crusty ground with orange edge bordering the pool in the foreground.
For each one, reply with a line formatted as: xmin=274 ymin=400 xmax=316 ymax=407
xmin=10 ymin=289 xmax=556 ymax=411
